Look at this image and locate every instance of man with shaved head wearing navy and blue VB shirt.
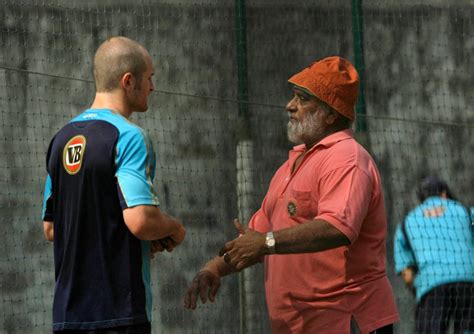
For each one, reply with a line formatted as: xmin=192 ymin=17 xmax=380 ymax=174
xmin=42 ymin=37 xmax=186 ymax=334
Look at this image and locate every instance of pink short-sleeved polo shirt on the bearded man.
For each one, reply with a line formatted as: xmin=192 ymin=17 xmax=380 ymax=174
xmin=249 ymin=130 xmax=399 ymax=334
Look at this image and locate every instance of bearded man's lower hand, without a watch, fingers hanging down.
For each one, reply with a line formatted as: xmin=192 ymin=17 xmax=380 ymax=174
xmin=184 ymin=270 xmax=221 ymax=310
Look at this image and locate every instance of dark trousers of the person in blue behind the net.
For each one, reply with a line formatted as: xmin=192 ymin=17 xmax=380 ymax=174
xmin=416 ymin=282 xmax=474 ymax=334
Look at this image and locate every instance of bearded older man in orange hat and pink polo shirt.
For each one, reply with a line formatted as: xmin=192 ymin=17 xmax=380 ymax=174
xmin=184 ymin=57 xmax=399 ymax=333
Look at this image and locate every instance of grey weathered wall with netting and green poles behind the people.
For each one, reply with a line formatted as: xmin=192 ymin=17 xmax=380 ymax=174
xmin=0 ymin=0 xmax=474 ymax=333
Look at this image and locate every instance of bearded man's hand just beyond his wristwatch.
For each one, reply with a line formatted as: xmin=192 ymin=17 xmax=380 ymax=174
xmin=219 ymin=219 xmax=266 ymax=271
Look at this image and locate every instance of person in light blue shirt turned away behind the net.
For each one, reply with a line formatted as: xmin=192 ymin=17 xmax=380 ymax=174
xmin=394 ymin=176 xmax=474 ymax=334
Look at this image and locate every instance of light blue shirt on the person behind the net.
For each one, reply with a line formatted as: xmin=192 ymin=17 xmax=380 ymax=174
xmin=394 ymin=196 xmax=474 ymax=302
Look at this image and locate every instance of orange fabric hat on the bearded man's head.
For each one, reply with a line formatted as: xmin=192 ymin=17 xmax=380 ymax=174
xmin=288 ymin=56 xmax=359 ymax=121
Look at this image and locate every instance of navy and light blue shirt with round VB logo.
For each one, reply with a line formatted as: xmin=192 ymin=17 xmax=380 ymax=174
xmin=43 ymin=109 xmax=159 ymax=330
